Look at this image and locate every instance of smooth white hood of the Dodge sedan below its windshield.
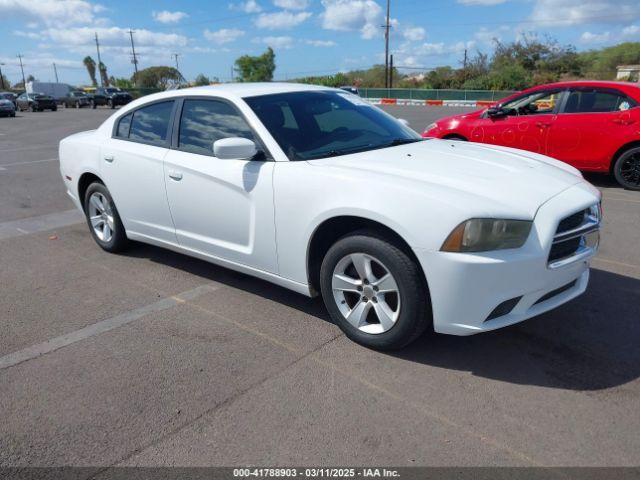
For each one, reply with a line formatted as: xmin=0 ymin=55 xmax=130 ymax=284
xmin=309 ymin=139 xmax=584 ymax=218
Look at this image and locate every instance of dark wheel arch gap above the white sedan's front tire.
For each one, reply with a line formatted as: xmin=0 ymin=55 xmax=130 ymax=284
xmin=306 ymin=215 xmax=429 ymax=295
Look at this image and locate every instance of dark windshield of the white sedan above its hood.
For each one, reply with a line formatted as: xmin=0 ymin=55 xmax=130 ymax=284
xmin=245 ymin=91 xmax=423 ymax=160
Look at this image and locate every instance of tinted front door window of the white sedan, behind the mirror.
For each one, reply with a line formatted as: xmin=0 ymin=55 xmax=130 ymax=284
xmin=178 ymin=100 xmax=255 ymax=155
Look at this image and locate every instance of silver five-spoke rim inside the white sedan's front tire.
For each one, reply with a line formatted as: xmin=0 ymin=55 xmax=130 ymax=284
xmin=331 ymin=253 xmax=400 ymax=334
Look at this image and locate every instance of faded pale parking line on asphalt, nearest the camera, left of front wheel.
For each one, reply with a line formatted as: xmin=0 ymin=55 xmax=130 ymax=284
xmin=0 ymin=284 xmax=219 ymax=370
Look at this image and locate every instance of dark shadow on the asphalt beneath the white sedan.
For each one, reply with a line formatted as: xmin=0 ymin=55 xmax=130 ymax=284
xmin=124 ymin=243 xmax=640 ymax=390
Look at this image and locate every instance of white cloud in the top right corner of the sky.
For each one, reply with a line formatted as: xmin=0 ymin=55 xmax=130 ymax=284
xmin=530 ymin=0 xmax=640 ymax=27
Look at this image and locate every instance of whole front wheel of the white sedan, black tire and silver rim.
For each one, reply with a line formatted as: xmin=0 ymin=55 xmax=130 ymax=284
xmin=320 ymin=231 xmax=431 ymax=350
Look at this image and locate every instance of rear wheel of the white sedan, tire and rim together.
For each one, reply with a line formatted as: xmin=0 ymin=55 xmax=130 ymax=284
xmin=84 ymin=182 xmax=128 ymax=253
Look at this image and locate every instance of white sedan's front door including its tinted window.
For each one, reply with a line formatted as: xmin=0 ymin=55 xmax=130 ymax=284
xmin=165 ymin=97 xmax=277 ymax=273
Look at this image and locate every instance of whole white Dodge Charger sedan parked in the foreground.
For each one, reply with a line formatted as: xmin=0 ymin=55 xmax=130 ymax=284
xmin=60 ymin=83 xmax=601 ymax=349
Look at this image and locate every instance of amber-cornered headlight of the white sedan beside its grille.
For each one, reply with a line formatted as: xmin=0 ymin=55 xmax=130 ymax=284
xmin=440 ymin=218 xmax=533 ymax=252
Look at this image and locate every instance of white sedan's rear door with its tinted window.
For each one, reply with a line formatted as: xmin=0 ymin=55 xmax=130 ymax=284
xmin=101 ymin=100 xmax=176 ymax=244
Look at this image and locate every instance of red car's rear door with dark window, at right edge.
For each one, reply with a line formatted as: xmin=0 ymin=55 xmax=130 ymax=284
xmin=549 ymin=87 xmax=637 ymax=171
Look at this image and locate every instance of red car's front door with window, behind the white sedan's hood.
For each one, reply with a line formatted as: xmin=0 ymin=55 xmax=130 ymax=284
xmin=471 ymin=89 xmax=561 ymax=154
